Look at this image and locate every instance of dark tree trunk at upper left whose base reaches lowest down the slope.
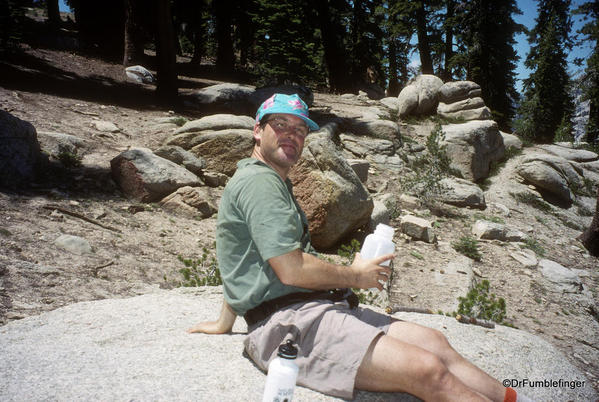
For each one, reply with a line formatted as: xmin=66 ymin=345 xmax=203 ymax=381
xmin=156 ymin=0 xmax=177 ymax=102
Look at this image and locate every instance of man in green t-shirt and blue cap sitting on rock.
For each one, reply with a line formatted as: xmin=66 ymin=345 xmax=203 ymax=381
xmin=188 ymin=94 xmax=516 ymax=401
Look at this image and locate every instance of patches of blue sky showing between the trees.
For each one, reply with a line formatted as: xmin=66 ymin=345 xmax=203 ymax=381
xmin=59 ymin=0 xmax=591 ymax=90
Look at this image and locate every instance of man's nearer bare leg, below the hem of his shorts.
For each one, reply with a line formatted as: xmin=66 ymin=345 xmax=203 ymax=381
xmin=356 ymin=335 xmax=489 ymax=401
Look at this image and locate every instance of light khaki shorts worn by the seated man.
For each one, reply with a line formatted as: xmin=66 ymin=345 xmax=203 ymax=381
xmin=244 ymin=300 xmax=391 ymax=398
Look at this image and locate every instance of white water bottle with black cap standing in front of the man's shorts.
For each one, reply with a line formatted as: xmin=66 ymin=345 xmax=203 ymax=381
xmin=262 ymin=340 xmax=299 ymax=402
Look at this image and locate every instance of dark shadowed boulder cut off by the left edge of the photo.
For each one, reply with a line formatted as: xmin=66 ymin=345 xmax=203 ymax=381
xmin=0 ymin=110 xmax=41 ymax=187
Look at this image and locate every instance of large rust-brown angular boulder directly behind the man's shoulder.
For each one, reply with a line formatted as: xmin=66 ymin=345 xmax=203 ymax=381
xmin=289 ymin=133 xmax=373 ymax=249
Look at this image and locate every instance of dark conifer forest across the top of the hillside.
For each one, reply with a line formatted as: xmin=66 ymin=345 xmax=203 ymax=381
xmin=0 ymin=0 xmax=599 ymax=145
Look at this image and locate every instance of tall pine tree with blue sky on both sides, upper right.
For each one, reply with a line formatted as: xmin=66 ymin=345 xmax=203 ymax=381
xmin=516 ymin=0 xmax=573 ymax=143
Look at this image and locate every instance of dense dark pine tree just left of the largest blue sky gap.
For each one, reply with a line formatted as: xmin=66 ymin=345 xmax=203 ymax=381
xmin=461 ymin=0 xmax=522 ymax=130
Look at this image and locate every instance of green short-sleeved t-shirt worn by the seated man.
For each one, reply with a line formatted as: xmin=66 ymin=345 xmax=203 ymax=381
xmin=216 ymin=158 xmax=316 ymax=315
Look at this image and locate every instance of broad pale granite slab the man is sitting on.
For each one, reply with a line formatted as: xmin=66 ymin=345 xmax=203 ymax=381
xmin=0 ymin=288 xmax=598 ymax=402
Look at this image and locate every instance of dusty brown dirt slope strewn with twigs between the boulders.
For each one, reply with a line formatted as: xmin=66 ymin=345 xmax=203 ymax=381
xmin=0 ymin=37 xmax=599 ymax=389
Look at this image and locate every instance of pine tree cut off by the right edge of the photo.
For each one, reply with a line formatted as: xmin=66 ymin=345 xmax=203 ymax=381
xmin=574 ymin=0 xmax=599 ymax=146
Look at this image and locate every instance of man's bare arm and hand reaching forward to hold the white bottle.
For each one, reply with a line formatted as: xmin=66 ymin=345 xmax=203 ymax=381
xmin=268 ymin=249 xmax=393 ymax=290
